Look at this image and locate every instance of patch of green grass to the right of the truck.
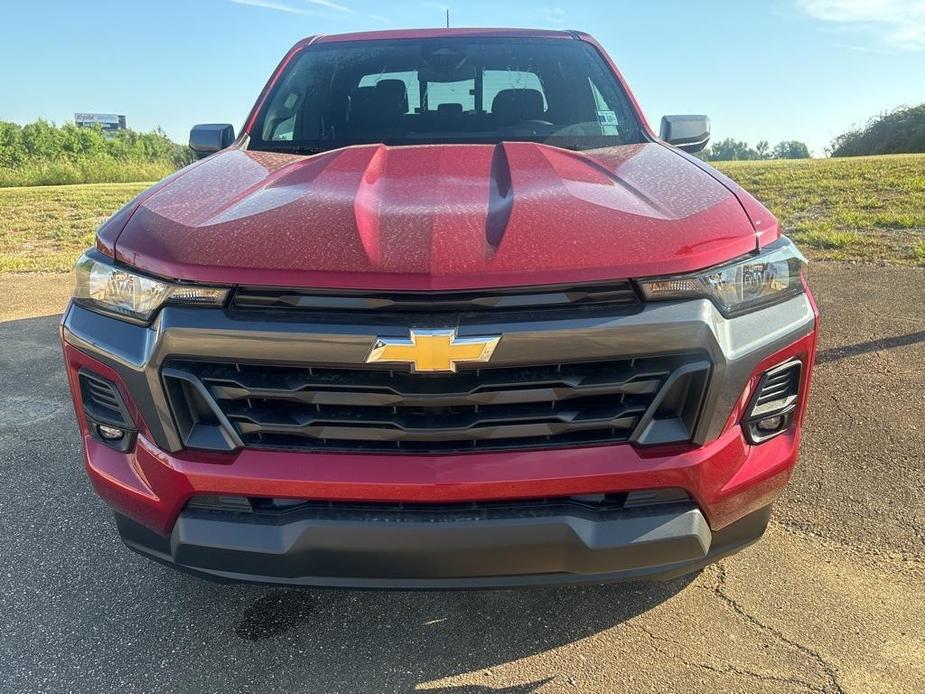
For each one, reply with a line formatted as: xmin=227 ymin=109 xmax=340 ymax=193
xmin=716 ymin=154 xmax=925 ymax=265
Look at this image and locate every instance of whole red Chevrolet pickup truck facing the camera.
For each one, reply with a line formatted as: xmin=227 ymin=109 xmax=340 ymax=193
xmin=61 ymin=29 xmax=817 ymax=588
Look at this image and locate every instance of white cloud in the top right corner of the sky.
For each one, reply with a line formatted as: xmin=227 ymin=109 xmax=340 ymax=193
xmin=797 ymin=0 xmax=925 ymax=50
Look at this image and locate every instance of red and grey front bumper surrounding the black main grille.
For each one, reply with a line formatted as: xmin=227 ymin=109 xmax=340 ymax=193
xmin=62 ymin=294 xmax=816 ymax=587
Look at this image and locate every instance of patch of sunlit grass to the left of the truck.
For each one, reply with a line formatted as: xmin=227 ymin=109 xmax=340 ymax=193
xmin=0 ymin=183 xmax=150 ymax=272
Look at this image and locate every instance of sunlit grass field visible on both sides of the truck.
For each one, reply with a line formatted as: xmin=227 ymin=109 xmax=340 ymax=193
xmin=0 ymin=155 xmax=925 ymax=273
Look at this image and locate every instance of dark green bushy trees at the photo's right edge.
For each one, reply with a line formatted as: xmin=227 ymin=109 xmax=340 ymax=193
xmin=829 ymin=104 xmax=925 ymax=157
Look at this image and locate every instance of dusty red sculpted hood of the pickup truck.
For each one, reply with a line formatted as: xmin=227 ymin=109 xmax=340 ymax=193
xmin=112 ymin=143 xmax=756 ymax=290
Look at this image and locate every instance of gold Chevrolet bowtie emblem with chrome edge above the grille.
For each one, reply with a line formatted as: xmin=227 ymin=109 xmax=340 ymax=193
xmin=366 ymin=330 xmax=501 ymax=372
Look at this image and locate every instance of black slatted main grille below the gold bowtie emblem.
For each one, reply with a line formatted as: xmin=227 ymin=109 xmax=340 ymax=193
xmin=163 ymin=354 xmax=710 ymax=453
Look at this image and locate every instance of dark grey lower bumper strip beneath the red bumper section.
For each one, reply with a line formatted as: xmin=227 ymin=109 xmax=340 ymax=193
xmin=116 ymin=503 xmax=770 ymax=589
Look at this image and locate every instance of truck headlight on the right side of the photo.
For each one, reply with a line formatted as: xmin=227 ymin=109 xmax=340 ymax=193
xmin=639 ymin=236 xmax=806 ymax=318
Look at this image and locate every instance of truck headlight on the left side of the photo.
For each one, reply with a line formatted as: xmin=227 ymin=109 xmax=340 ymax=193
xmin=74 ymin=251 xmax=228 ymax=323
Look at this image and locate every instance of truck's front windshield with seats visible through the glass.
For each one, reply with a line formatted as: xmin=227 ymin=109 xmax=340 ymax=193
xmin=249 ymin=38 xmax=642 ymax=153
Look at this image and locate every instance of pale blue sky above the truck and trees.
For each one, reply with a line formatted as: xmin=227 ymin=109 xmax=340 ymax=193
xmin=0 ymin=0 xmax=925 ymax=155
